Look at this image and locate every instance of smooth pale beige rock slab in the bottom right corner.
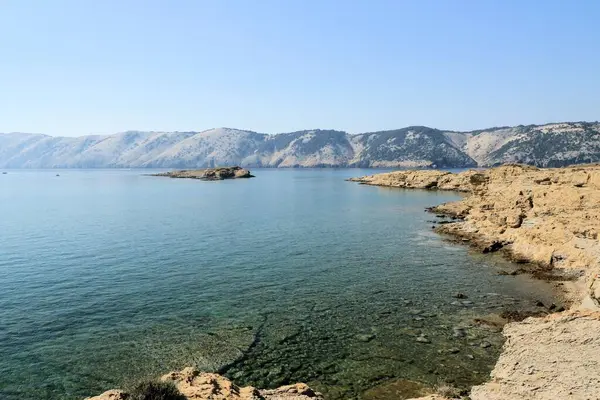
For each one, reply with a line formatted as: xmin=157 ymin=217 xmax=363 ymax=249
xmin=470 ymin=312 xmax=600 ymax=400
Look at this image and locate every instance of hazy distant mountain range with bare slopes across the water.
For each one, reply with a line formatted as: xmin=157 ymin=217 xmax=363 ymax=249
xmin=0 ymin=122 xmax=600 ymax=168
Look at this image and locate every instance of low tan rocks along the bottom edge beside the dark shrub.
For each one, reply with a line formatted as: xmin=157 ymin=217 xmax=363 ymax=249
xmin=87 ymin=367 xmax=323 ymax=400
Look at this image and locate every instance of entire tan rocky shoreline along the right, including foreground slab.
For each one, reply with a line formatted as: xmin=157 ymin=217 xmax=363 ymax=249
xmin=350 ymin=165 xmax=600 ymax=400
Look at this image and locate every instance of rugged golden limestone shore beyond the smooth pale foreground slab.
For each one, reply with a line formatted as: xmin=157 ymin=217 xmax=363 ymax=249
xmin=351 ymin=164 xmax=600 ymax=305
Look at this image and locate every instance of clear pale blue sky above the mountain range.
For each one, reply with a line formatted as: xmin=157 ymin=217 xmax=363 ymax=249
xmin=0 ymin=0 xmax=600 ymax=136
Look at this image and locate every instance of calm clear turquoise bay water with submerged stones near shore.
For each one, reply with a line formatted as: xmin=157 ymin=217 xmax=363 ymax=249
xmin=0 ymin=169 xmax=553 ymax=400
